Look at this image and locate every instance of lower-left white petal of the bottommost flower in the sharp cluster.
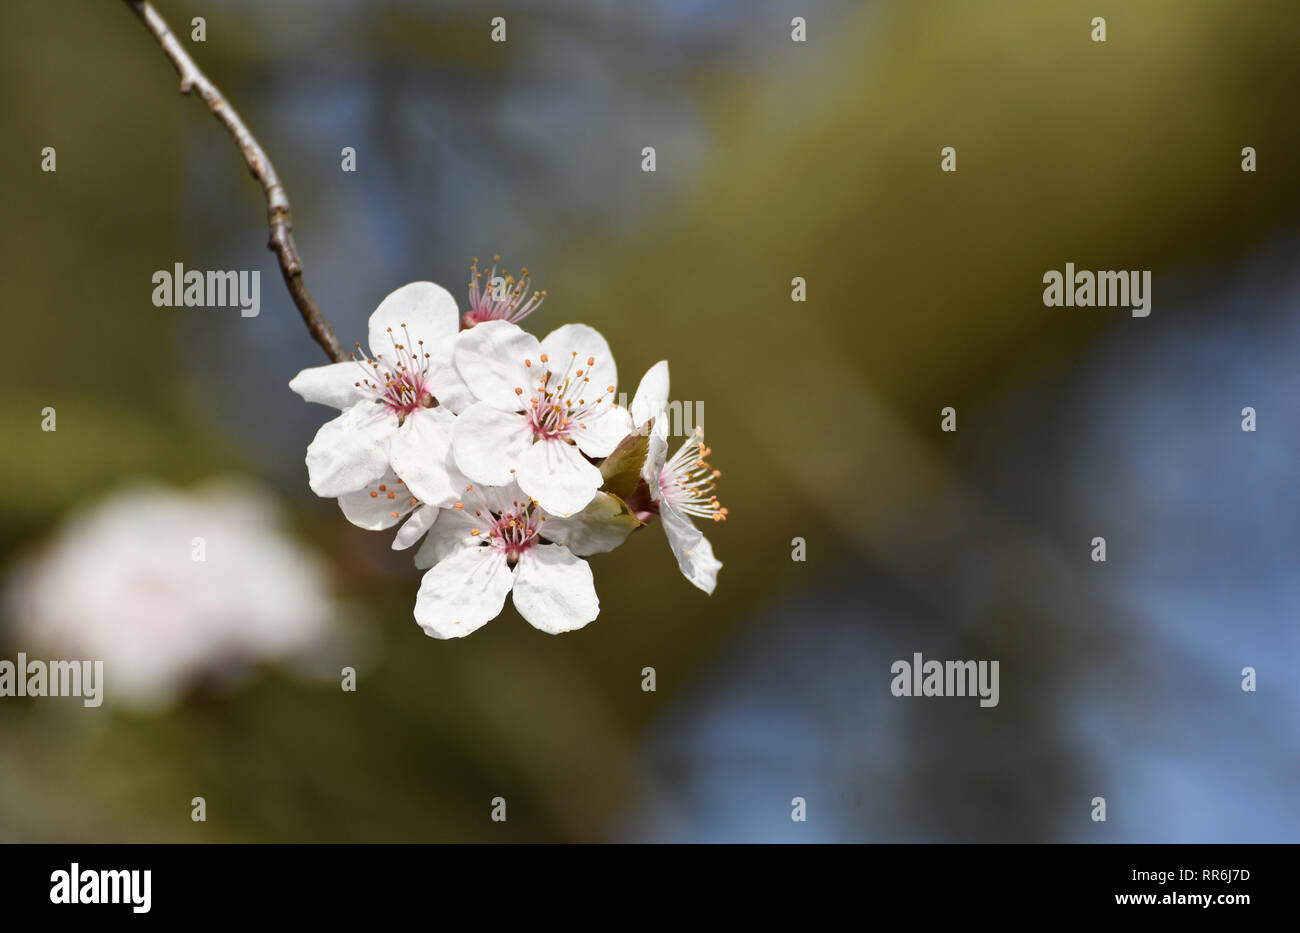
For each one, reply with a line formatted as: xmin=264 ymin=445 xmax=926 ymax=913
xmin=415 ymin=546 xmax=514 ymax=638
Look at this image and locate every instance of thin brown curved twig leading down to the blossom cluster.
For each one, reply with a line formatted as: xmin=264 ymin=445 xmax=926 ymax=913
xmin=125 ymin=0 xmax=347 ymax=363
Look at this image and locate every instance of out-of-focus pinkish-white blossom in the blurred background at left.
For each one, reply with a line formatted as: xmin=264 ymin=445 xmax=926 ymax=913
xmin=5 ymin=481 xmax=341 ymax=708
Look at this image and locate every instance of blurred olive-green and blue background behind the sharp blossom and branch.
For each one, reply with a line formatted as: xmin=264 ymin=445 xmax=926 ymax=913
xmin=0 ymin=0 xmax=1300 ymax=842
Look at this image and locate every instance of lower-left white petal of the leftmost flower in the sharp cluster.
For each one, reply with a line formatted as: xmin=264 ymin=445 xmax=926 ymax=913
xmin=307 ymin=402 xmax=398 ymax=499
